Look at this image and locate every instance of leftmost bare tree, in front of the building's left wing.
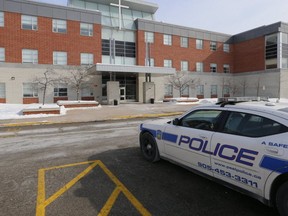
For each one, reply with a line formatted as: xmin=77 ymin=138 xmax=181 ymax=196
xmin=33 ymin=68 xmax=57 ymax=105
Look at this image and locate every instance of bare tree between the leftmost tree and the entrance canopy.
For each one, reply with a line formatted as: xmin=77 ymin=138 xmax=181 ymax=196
xmin=61 ymin=66 xmax=91 ymax=100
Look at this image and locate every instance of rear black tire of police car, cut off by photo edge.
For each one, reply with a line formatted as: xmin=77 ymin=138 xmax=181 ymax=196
xmin=276 ymin=182 xmax=288 ymax=216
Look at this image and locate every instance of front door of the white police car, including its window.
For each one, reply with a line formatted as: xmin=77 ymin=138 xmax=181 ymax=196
xmin=162 ymin=109 xmax=222 ymax=175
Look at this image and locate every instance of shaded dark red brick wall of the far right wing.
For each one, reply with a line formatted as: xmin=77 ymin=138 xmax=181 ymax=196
xmin=234 ymin=37 xmax=265 ymax=73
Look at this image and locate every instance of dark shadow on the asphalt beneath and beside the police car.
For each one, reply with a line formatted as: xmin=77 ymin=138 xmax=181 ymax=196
xmin=74 ymin=148 xmax=277 ymax=216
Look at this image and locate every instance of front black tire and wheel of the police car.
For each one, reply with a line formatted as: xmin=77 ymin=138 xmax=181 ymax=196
xmin=140 ymin=133 xmax=160 ymax=162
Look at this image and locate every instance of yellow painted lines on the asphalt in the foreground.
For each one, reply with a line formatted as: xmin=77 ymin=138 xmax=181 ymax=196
xmin=36 ymin=160 xmax=151 ymax=216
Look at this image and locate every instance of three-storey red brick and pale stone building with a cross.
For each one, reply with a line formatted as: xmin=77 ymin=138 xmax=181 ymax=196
xmin=0 ymin=0 xmax=288 ymax=103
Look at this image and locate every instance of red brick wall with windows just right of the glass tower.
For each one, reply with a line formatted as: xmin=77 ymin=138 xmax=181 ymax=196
xmin=137 ymin=30 xmax=234 ymax=72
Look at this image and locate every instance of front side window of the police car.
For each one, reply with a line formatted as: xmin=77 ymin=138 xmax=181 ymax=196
xmin=180 ymin=110 xmax=222 ymax=131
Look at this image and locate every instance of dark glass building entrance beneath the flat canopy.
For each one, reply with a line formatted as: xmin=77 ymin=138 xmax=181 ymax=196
xmin=102 ymin=72 xmax=138 ymax=102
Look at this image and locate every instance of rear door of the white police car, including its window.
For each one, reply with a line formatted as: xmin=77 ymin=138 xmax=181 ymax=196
xmin=211 ymin=112 xmax=284 ymax=196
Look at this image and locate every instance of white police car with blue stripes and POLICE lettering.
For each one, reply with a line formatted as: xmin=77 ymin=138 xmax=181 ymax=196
xmin=139 ymin=98 xmax=288 ymax=215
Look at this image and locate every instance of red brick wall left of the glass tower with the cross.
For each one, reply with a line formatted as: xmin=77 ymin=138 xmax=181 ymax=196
xmin=0 ymin=12 xmax=102 ymax=65
